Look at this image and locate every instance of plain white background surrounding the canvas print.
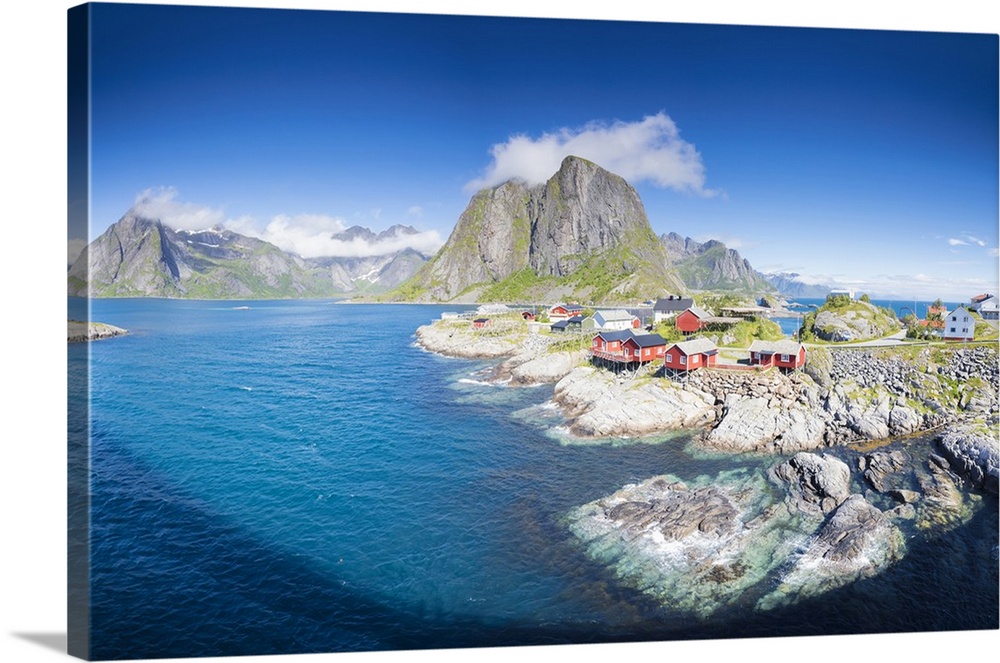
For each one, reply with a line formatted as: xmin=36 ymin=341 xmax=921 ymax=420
xmin=0 ymin=0 xmax=1000 ymax=663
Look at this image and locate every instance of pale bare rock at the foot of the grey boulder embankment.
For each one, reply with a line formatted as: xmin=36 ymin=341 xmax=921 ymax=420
xmin=701 ymin=395 xmax=825 ymax=453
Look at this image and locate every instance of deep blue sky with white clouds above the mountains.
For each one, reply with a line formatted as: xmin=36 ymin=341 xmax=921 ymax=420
xmin=76 ymin=5 xmax=1000 ymax=300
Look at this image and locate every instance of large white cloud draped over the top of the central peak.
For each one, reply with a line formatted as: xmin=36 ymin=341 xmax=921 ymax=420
xmin=465 ymin=112 xmax=717 ymax=196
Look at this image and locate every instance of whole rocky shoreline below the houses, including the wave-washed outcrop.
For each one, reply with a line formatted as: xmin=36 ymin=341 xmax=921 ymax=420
xmin=410 ymin=323 xmax=1000 ymax=618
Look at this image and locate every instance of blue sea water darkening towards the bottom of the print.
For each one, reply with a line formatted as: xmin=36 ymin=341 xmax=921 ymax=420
xmin=69 ymin=299 xmax=998 ymax=659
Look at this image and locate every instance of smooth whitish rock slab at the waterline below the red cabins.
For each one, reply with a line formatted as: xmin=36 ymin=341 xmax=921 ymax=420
xmin=553 ymin=366 xmax=715 ymax=437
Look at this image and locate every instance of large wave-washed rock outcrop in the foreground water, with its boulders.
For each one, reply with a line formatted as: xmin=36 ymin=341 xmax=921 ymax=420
xmin=568 ymin=454 xmax=905 ymax=617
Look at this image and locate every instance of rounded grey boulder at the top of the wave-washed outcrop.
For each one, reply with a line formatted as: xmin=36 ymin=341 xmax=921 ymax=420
xmin=770 ymin=452 xmax=851 ymax=516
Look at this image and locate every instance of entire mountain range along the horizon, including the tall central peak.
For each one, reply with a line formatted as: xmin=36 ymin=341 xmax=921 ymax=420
xmin=68 ymin=156 xmax=812 ymax=304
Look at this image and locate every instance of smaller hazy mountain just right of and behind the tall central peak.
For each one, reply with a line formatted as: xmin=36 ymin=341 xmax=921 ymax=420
xmin=660 ymin=232 xmax=774 ymax=292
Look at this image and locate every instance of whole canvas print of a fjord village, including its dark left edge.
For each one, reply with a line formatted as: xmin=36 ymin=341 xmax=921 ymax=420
xmin=66 ymin=3 xmax=1000 ymax=660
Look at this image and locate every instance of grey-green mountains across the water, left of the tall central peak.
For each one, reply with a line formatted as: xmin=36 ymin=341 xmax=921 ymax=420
xmin=68 ymin=211 xmax=427 ymax=299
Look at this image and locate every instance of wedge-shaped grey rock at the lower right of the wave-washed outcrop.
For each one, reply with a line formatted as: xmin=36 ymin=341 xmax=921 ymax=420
xmin=758 ymin=495 xmax=905 ymax=609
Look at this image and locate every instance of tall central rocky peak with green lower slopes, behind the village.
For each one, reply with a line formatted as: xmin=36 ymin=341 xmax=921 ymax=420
xmin=389 ymin=156 xmax=686 ymax=302
